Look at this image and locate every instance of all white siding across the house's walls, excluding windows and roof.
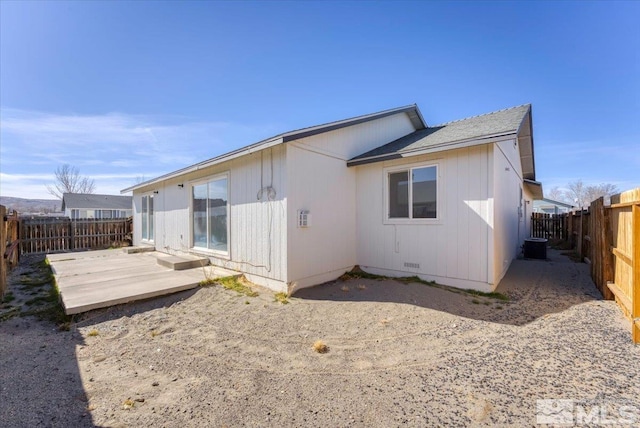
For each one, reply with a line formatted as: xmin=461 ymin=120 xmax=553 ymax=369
xmin=126 ymin=107 xmax=531 ymax=292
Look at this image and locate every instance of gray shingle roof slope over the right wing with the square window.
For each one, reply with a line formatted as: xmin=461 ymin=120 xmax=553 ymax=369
xmin=348 ymin=104 xmax=531 ymax=165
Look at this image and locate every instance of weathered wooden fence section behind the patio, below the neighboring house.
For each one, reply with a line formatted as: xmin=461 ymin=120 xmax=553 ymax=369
xmin=20 ymin=217 xmax=132 ymax=254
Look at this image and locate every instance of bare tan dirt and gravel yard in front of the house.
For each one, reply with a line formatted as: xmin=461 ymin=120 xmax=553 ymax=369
xmin=0 ymin=250 xmax=640 ymax=427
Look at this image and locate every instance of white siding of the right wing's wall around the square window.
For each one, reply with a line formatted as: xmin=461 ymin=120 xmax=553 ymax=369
xmin=356 ymin=145 xmax=492 ymax=289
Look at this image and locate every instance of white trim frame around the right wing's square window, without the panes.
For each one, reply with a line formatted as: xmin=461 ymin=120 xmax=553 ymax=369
xmin=382 ymin=161 xmax=444 ymax=224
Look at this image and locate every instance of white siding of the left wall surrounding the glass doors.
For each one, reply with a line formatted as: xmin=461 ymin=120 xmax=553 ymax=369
xmin=133 ymin=145 xmax=287 ymax=290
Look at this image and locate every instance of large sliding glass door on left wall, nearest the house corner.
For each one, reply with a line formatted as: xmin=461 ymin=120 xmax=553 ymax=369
xmin=191 ymin=175 xmax=229 ymax=253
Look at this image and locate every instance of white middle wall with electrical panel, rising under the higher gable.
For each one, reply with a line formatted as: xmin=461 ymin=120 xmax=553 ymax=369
xmin=287 ymin=113 xmax=415 ymax=291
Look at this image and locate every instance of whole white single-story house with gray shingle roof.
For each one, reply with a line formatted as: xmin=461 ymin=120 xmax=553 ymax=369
xmin=122 ymin=105 xmax=542 ymax=292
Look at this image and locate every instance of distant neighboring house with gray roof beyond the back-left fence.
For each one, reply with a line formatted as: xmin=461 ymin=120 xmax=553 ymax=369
xmin=62 ymin=193 xmax=133 ymax=219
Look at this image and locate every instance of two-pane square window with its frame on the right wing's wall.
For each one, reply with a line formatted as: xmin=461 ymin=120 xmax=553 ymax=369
xmin=387 ymin=165 xmax=438 ymax=220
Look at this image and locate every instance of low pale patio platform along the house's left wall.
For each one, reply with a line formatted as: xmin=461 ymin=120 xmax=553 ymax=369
xmin=47 ymin=250 xmax=238 ymax=315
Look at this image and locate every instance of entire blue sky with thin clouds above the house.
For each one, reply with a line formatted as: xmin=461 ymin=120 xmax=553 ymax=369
xmin=0 ymin=0 xmax=640 ymax=198
